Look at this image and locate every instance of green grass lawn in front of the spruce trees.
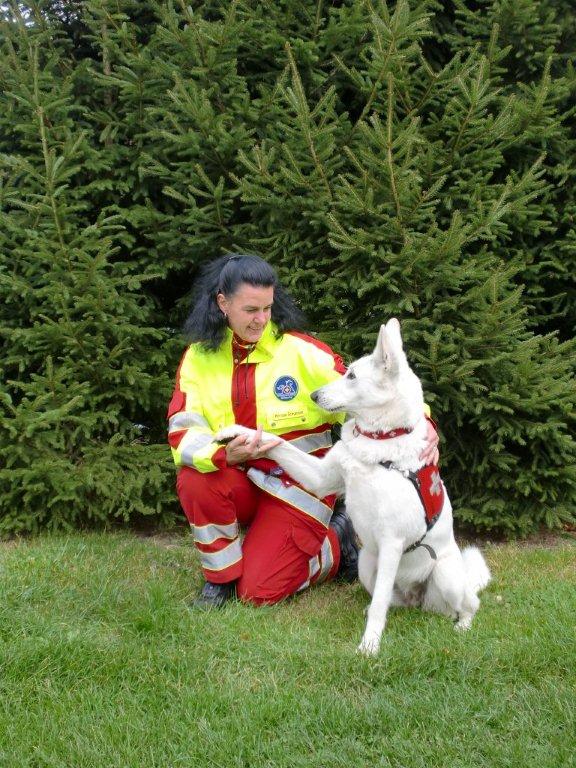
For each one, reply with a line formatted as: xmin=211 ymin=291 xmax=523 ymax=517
xmin=0 ymin=534 xmax=576 ymax=768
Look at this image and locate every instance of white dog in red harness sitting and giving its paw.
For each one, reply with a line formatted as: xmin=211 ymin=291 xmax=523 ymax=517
xmin=216 ymin=318 xmax=490 ymax=655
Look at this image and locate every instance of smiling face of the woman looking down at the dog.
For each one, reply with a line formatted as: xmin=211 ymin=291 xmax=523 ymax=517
xmin=217 ymin=283 xmax=274 ymax=344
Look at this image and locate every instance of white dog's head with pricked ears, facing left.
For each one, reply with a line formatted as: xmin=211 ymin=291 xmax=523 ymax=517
xmin=311 ymin=318 xmax=424 ymax=428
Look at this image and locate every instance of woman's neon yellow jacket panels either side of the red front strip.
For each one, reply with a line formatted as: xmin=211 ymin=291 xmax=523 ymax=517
xmin=168 ymin=323 xmax=345 ymax=472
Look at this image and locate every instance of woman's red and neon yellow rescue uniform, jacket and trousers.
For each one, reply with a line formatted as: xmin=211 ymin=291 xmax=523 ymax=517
xmin=168 ymin=323 xmax=345 ymax=603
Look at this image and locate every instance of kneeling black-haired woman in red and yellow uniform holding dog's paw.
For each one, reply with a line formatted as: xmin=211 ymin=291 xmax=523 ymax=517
xmin=168 ymin=255 xmax=437 ymax=608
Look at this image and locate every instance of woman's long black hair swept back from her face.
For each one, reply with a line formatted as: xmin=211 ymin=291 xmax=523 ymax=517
xmin=184 ymin=253 xmax=306 ymax=350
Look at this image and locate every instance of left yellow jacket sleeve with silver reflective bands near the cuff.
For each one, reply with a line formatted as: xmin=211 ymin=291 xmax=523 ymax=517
xmin=168 ymin=353 xmax=226 ymax=472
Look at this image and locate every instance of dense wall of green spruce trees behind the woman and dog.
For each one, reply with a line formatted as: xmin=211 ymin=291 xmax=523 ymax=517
xmin=0 ymin=0 xmax=576 ymax=535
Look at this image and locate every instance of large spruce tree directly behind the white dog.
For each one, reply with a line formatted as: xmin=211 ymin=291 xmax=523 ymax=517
xmin=227 ymin=2 xmax=575 ymax=532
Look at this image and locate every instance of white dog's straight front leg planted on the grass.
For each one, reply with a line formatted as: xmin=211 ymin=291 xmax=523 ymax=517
xmin=358 ymin=540 xmax=402 ymax=656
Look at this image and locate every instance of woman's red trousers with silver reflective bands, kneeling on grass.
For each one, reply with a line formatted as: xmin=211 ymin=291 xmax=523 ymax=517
xmin=176 ymin=467 xmax=340 ymax=604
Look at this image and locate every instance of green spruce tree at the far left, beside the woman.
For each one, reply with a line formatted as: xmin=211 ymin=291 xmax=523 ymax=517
xmin=0 ymin=4 xmax=176 ymax=532
